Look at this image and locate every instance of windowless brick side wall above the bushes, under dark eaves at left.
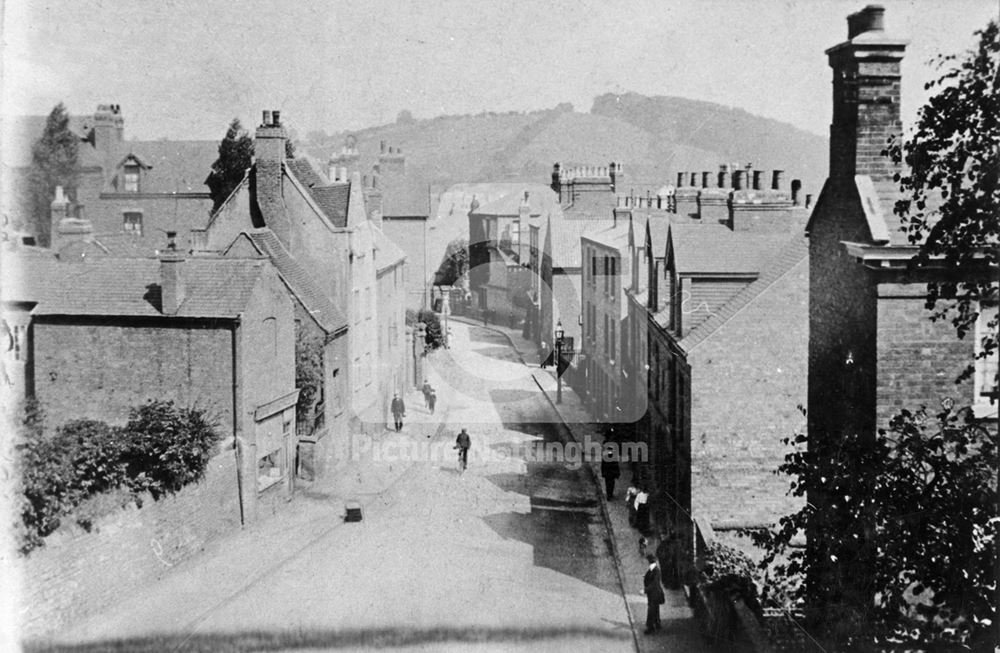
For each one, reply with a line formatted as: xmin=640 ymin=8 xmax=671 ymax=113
xmin=32 ymin=318 xmax=233 ymax=434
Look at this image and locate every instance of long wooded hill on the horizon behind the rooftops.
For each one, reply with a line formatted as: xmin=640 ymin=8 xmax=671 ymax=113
xmin=301 ymin=93 xmax=828 ymax=195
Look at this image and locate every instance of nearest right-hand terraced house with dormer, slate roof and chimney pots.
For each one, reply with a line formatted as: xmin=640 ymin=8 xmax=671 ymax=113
xmin=629 ymin=159 xmax=808 ymax=564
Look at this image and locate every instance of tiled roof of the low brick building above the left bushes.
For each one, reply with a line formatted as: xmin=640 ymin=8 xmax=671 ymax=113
xmin=3 ymin=252 xmax=268 ymax=319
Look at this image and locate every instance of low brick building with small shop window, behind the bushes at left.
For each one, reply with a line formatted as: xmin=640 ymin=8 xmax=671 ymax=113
xmin=3 ymin=238 xmax=298 ymax=523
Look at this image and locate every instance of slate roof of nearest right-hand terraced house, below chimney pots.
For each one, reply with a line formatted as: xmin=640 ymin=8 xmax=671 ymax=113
xmin=669 ymin=224 xmax=788 ymax=274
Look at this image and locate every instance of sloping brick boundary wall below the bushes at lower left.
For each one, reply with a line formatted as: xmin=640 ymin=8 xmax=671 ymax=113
xmin=20 ymin=448 xmax=240 ymax=637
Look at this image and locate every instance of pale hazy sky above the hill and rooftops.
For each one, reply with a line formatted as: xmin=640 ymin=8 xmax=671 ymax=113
xmin=3 ymin=0 xmax=998 ymax=139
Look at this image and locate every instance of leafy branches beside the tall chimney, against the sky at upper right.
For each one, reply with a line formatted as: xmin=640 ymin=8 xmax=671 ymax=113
xmin=885 ymin=21 xmax=1000 ymax=386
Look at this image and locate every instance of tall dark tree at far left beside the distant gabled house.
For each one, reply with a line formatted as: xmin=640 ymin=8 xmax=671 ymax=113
xmin=29 ymin=102 xmax=80 ymax=246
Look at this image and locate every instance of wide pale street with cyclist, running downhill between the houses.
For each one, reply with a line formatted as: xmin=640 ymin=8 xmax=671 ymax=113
xmin=45 ymin=324 xmax=634 ymax=651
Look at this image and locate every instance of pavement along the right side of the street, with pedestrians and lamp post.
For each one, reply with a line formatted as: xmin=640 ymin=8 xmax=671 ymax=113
xmin=452 ymin=316 xmax=712 ymax=653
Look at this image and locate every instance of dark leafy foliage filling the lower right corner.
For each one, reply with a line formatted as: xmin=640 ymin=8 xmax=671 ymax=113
xmin=753 ymin=407 xmax=998 ymax=651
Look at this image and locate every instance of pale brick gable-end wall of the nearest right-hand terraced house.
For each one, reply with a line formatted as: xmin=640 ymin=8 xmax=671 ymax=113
xmin=688 ymin=259 xmax=809 ymax=524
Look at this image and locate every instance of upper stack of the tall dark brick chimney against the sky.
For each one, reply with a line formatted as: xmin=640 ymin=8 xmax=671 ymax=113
xmin=826 ymin=5 xmax=908 ymax=181
